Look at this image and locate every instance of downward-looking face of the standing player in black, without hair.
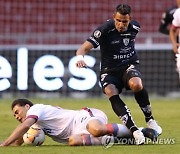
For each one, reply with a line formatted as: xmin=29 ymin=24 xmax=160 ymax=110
xmin=113 ymin=12 xmax=131 ymax=32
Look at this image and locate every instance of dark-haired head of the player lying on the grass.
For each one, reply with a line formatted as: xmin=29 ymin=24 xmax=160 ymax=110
xmin=11 ymin=99 xmax=33 ymax=122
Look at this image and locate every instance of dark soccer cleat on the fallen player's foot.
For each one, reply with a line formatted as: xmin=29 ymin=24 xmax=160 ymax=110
xmin=141 ymin=128 xmax=158 ymax=142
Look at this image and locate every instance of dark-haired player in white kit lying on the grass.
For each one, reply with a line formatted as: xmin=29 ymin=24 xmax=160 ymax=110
xmin=0 ymin=99 xmax=157 ymax=146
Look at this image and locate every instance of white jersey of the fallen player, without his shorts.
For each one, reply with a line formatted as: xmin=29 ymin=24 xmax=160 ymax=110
xmin=26 ymin=104 xmax=79 ymax=143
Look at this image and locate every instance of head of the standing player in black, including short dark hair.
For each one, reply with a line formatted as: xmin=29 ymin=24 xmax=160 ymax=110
xmin=113 ymin=4 xmax=131 ymax=32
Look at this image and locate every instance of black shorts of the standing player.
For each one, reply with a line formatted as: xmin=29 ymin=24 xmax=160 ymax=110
xmin=100 ymin=64 xmax=141 ymax=93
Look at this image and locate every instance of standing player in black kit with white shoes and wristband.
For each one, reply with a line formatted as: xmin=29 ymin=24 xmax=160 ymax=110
xmin=76 ymin=4 xmax=162 ymax=145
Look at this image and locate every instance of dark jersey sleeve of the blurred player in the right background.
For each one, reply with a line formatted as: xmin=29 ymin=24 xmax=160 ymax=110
xmin=159 ymin=6 xmax=178 ymax=35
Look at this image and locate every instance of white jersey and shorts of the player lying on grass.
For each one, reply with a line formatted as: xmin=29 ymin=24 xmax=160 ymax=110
xmin=26 ymin=104 xmax=107 ymax=143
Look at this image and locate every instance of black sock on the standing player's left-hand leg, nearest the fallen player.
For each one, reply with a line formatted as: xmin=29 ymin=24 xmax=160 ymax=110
xmin=109 ymin=95 xmax=138 ymax=132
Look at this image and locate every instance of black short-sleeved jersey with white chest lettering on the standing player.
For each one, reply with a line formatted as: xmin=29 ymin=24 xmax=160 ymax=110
xmin=87 ymin=19 xmax=140 ymax=69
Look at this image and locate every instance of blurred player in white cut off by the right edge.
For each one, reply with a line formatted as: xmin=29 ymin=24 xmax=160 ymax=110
xmin=170 ymin=7 xmax=180 ymax=81
